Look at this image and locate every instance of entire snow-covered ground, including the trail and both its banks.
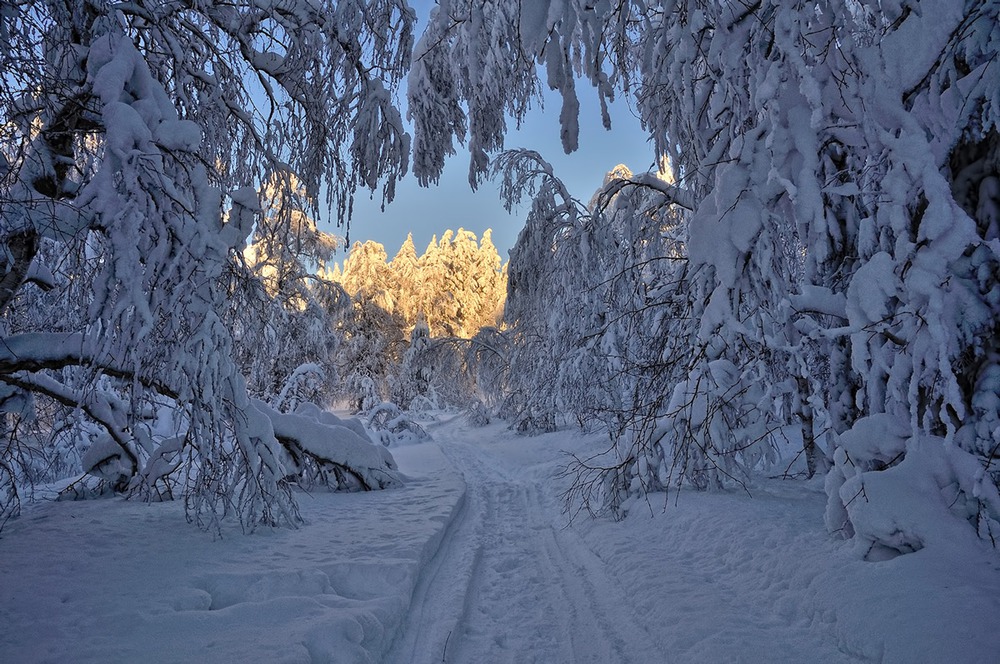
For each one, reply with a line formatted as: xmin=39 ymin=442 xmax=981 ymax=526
xmin=0 ymin=419 xmax=1000 ymax=664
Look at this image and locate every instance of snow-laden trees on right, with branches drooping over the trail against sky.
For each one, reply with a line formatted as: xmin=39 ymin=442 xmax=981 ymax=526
xmin=408 ymin=0 xmax=1000 ymax=552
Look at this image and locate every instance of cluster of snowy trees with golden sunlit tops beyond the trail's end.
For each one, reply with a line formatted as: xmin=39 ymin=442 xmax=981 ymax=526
xmin=338 ymin=228 xmax=506 ymax=410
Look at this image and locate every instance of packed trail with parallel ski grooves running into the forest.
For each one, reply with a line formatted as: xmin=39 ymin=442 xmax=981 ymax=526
xmin=386 ymin=427 xmax=665 ymax=664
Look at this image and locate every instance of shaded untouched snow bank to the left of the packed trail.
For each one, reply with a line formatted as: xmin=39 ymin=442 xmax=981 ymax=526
xmin=0 ymin=443 xmax=465 ymax=663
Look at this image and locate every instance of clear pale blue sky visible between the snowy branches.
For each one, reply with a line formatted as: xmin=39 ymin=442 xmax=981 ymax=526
xmin=320 ymin=0 xmax=655 ymax=262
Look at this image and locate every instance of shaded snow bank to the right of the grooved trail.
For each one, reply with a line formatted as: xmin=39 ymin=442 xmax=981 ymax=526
xmin=474 ymin=430 xmax=1000 ymax=664
